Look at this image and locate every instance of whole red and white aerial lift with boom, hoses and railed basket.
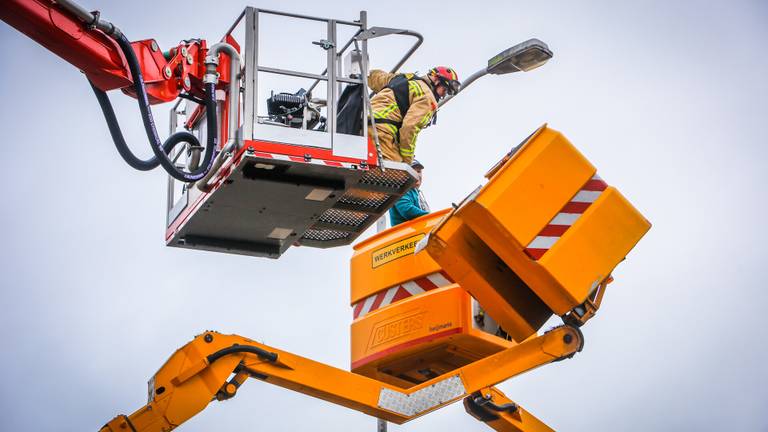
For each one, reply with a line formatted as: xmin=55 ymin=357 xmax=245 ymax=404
xmin=0 ymin=0 xmax=421 ymax=258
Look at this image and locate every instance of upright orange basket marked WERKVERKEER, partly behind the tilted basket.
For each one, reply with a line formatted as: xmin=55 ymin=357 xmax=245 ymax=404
xmin=351 ymin=210 xmax=514 ymax=388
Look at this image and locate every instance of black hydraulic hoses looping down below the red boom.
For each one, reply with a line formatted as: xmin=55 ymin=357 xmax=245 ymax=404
xmin=91 ymin=34 xmax=218 ymax=183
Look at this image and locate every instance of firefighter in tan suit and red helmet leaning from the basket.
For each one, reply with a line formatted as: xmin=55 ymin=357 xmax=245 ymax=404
xmin=368 ymin=66 xmax=461 ymax=163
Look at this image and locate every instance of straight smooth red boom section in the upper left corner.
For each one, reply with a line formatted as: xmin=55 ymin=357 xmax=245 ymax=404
xmin=0 ymin=0 xmax=132 ymax=91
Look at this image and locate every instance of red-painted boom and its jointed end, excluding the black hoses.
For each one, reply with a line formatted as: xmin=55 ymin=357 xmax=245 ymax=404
xmin=0 ymin=0 xmax=229 ymax=104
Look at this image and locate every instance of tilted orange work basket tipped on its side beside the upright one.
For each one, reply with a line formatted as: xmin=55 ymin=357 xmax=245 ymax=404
xmin=426 ymin=125 xmax=651 ymax=341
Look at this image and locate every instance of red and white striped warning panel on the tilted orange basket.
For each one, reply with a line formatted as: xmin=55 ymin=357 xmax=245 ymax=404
xmin=525 ymin=174 xmax=608 ymax=261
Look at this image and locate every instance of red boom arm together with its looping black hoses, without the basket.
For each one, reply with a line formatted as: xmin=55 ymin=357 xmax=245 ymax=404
xmin=0 ymin=0 xmax=239 ymax=182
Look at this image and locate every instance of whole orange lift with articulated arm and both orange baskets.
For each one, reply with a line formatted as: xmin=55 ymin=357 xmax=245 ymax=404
xmin=97 ymin=126 xmax=650 ymax=432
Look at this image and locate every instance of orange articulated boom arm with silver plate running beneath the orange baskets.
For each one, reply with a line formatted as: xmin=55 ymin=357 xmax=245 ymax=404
xmin=101 ymin=326 xmax=583 ymax=432
